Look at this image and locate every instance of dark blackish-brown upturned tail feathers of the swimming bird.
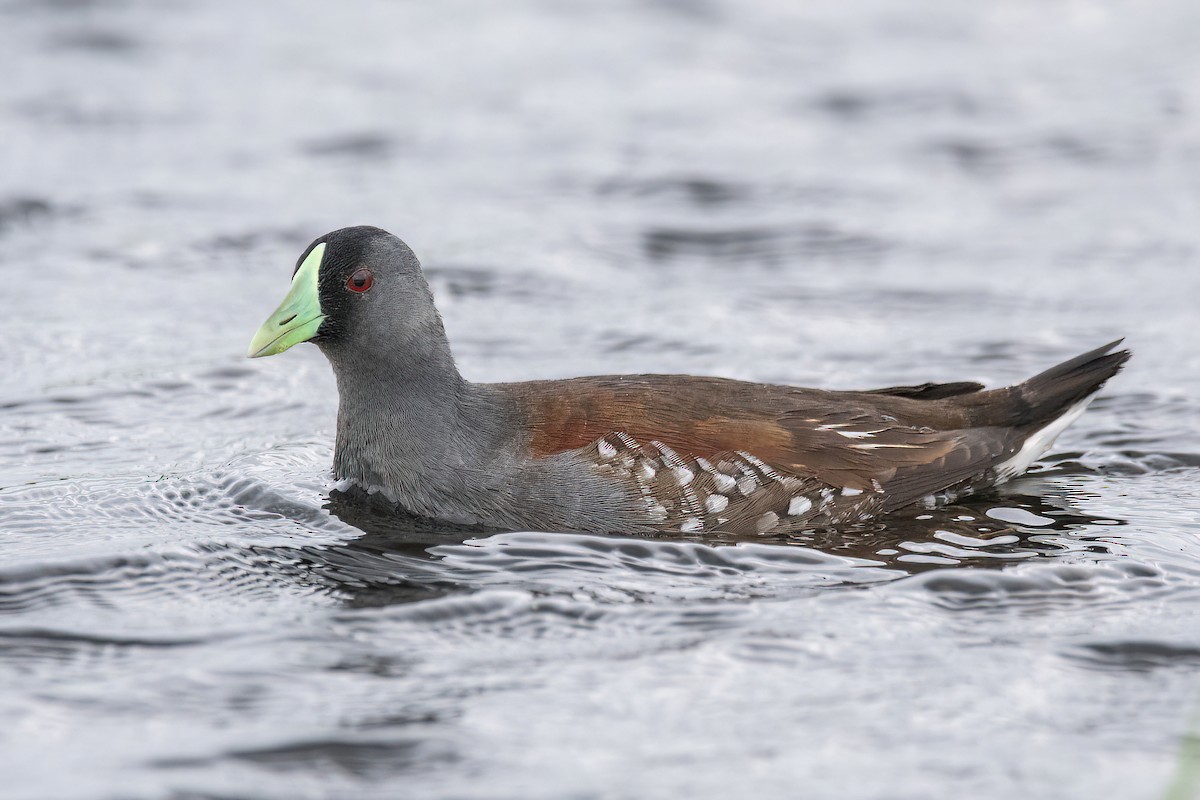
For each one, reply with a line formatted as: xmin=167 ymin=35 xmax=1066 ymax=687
xmin=1010 ymin=339 xmax=1133 ymax=426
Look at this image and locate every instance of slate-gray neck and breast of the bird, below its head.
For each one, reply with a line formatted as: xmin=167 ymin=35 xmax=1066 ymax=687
xmin=322 ymin=324 xmax=517 ymax=523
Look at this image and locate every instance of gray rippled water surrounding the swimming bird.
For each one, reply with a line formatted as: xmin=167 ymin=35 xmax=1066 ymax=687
xmin=0 ymin=0 xmax=1200 ymax=800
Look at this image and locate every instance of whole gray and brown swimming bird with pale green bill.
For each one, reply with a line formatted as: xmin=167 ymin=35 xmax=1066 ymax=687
xmin=247 ymin=227 xmax=1130 ymax=535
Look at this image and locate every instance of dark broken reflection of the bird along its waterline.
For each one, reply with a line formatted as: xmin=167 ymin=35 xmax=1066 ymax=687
xmin=301 ymin=474 xmax=1124 ymax=607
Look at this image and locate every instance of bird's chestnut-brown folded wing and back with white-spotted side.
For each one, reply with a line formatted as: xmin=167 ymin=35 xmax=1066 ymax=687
xmin=502 ymin=375 xmax=1013 ymax=533
